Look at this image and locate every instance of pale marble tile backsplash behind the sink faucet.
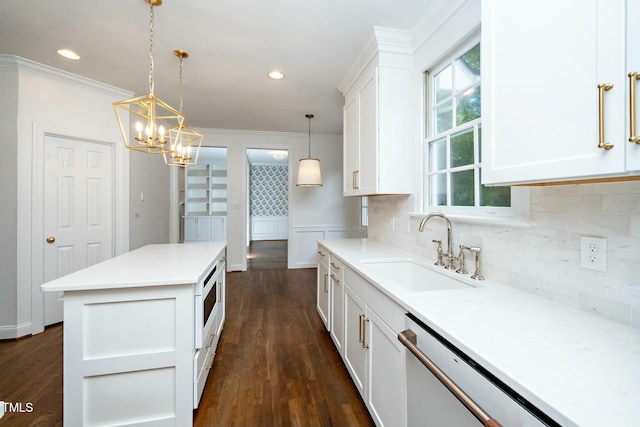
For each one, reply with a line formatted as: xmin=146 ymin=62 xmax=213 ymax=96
xmin=368 ymin=182 xmax=640 ymax=328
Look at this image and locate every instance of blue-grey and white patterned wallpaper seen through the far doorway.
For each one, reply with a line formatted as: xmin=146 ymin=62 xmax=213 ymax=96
xmin=249 ymin=165 xmax=289 ymax=216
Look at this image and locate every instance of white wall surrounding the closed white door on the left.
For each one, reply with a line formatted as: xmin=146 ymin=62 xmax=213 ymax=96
xmin=0 ymin=55 xmax=130 ymax=338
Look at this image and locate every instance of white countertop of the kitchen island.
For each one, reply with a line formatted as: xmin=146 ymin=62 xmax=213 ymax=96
xmin=41 ymin=242 xmax=227 ymax=292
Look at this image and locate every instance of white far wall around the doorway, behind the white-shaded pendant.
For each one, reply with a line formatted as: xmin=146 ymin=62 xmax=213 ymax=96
xmin=188 ymin=129 xmax=359 ymax=270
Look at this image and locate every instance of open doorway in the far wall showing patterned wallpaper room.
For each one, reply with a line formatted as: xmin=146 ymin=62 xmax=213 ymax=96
xmin=247 ymin=148 xmax=289 ymax=269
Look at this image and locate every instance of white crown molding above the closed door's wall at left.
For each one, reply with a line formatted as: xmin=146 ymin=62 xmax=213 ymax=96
xmin=0 ymin=54 xmax=134 ymax=98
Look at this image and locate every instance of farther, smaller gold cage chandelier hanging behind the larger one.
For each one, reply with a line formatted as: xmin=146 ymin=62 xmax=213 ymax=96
xmin=162 ymin=50 xmax=202 ymax=168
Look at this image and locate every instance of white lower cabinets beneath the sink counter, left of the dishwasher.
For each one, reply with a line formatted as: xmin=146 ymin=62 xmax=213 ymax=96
xmin=318 ymin=244 xmax=407 ymax=427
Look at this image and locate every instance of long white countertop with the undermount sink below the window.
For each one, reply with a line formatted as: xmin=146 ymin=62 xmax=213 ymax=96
xmin=318 ymin=239 xmax=640 ymax=427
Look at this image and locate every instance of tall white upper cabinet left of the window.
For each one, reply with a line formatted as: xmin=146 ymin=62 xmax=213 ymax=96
xmin=340 ymin=27 xmax=412 ymax=196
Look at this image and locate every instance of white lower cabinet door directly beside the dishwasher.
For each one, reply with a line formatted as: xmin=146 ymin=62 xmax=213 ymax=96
xmin=367 ymin=310 xmax=407 ymax=427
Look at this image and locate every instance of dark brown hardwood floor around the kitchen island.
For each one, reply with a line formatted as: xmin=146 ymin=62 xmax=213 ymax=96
xmin=0 ymin=247 xmax=374 ymax=427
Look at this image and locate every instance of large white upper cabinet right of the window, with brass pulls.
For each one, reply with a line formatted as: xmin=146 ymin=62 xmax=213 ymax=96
xmin=481 ymin=0 xmax=640 ymax=184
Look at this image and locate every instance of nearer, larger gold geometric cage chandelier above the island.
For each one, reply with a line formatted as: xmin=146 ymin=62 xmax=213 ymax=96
xmin=113 ymin=0 xmax=184 ymax=154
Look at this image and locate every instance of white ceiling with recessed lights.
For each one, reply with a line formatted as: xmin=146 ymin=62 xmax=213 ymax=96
xmin=0 ymin=0 xmax=433 ymax=135
